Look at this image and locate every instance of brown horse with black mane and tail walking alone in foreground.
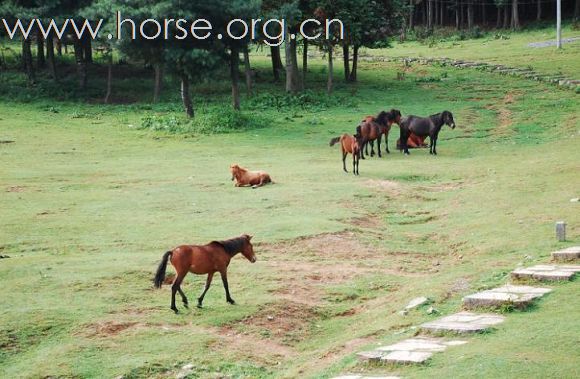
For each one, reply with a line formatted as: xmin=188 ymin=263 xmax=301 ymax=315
xmin=153 ymin=234 xmax=256 ymax=313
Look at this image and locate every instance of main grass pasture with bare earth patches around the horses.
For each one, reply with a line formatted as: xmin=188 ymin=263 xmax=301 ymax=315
xmin=0 ymin=37 xmax=580 ymax=378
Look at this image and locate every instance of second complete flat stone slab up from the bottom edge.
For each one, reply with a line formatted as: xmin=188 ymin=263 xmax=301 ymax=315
xmin=421 ymin=312 xmax=505 ymax=334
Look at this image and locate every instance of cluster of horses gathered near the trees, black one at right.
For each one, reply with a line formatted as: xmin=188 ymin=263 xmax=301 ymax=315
xmin=330 ymin=109 xmax=455 ymax=175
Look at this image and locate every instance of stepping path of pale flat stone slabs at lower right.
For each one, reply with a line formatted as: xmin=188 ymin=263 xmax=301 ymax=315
xmin=333 ymin=246 xmax=580 ymax=379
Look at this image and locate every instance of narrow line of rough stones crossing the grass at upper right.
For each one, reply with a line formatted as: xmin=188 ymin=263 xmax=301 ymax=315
xmin=360 ymin=56 xmax=580 ymax=91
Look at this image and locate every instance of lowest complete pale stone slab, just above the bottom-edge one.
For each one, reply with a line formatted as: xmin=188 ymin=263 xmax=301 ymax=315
xmin=357 ymin=337 xmax=467 ymax=364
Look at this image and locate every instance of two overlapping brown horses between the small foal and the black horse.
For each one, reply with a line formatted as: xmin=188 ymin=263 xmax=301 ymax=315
xmin=356 ymin=109 xmax=401 ymax=159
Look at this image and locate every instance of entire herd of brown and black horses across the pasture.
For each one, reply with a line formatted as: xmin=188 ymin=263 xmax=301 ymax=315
xmin=153 ymin=109 xmax=455 ymax=313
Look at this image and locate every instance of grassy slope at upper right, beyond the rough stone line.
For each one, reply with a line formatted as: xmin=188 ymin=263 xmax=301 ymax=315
xmin=364 ymin=25 xmax=580 ymax=79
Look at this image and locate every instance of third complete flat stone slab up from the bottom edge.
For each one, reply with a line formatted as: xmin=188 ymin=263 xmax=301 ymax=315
xmin=463 ymin=284 xmax=552 ymax=309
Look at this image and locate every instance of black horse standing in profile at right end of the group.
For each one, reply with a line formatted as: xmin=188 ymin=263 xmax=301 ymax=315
xmin=399 ymin=111 xmax=455 ymax=155
